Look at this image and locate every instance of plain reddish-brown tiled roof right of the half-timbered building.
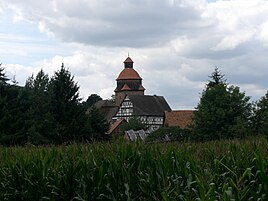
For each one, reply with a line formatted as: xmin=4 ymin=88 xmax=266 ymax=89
xmin=165 ymin=110 xmax=194 ymax=128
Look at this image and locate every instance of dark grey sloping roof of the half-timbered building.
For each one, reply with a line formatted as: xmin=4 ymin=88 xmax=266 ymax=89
xmin=128 ymin=95 xmax=171 ymax=116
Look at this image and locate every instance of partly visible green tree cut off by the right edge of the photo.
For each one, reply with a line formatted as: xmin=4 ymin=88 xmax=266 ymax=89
xmin=253 ymin=91 xmax=268 ymax=135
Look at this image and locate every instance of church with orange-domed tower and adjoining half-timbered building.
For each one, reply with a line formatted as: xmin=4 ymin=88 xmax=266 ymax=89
xmin=95 ymin=57 xmax=192 ymax=134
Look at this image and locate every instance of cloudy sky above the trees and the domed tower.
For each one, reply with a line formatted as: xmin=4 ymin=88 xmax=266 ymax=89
xmin=0 ymin=0 xmax=268 ymax=110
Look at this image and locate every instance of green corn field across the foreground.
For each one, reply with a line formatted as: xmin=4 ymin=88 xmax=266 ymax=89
xmin=0 ymin=137 xmax=268 ymax=201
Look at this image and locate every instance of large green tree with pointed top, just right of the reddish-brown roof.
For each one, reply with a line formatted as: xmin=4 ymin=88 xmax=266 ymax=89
xmin=194 ymin=68 xmax=251 ymax=140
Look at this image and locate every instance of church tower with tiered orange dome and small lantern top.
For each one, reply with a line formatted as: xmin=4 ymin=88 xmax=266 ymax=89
xmin=114 ymin=57 xmax=145 ymax=105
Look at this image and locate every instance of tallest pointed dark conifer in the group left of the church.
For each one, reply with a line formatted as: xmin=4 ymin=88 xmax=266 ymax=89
xmin=49 ymin=64 xmax=80 ymax=143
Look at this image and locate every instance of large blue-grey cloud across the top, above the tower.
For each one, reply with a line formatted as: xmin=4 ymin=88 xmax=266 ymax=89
xmin=4 ymin=0 xmax=204 ymax=47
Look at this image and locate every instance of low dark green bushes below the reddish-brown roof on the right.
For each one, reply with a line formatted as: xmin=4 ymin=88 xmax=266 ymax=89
xmin=146 ymin=127 xmax=192 ymax=142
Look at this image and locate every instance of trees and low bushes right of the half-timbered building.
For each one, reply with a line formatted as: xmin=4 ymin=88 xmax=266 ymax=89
xmin=147 ymin=67 xmax=268 ymax=141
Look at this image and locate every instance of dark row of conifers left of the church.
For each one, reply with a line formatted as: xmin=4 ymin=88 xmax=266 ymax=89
xmin=0 ymin=65 xmax=108 ymax=145
